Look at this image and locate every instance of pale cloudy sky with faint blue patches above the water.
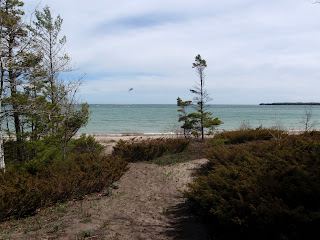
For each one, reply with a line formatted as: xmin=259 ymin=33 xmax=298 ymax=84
xmin=24 ymin=0 xmax=320 ymax=104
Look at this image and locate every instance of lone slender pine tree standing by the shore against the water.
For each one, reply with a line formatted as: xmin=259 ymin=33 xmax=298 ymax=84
xmin=177 ymin=54 xmax=223 ymax=140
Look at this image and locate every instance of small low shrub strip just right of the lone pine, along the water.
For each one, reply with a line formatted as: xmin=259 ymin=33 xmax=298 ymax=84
xmin=208 ymin=127 xmax=287 ymax=145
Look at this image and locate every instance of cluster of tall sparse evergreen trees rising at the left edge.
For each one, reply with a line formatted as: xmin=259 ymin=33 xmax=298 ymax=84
xmin=0 ymin=0 xmax=89 ymax=170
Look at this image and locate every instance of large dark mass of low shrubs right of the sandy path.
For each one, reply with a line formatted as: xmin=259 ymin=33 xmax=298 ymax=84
xmin=185 ymin=133 xmax=320 ymax=239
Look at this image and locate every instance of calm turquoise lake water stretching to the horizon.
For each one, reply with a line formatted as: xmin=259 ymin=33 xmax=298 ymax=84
xmin=78 ymin=104 xmax=320 ymax=135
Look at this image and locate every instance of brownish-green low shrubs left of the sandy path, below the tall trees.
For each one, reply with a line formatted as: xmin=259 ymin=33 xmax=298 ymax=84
xmin=0 ymin=138 xmax=127 ymax=220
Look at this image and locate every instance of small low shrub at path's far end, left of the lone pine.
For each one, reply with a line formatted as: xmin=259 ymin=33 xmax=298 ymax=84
xmin=112 ymin=138 xmax=190 ymax=162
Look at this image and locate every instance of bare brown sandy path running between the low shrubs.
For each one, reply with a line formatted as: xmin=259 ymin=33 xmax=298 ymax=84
xmin=0 ymin=137 xmax=209 ymax=240
